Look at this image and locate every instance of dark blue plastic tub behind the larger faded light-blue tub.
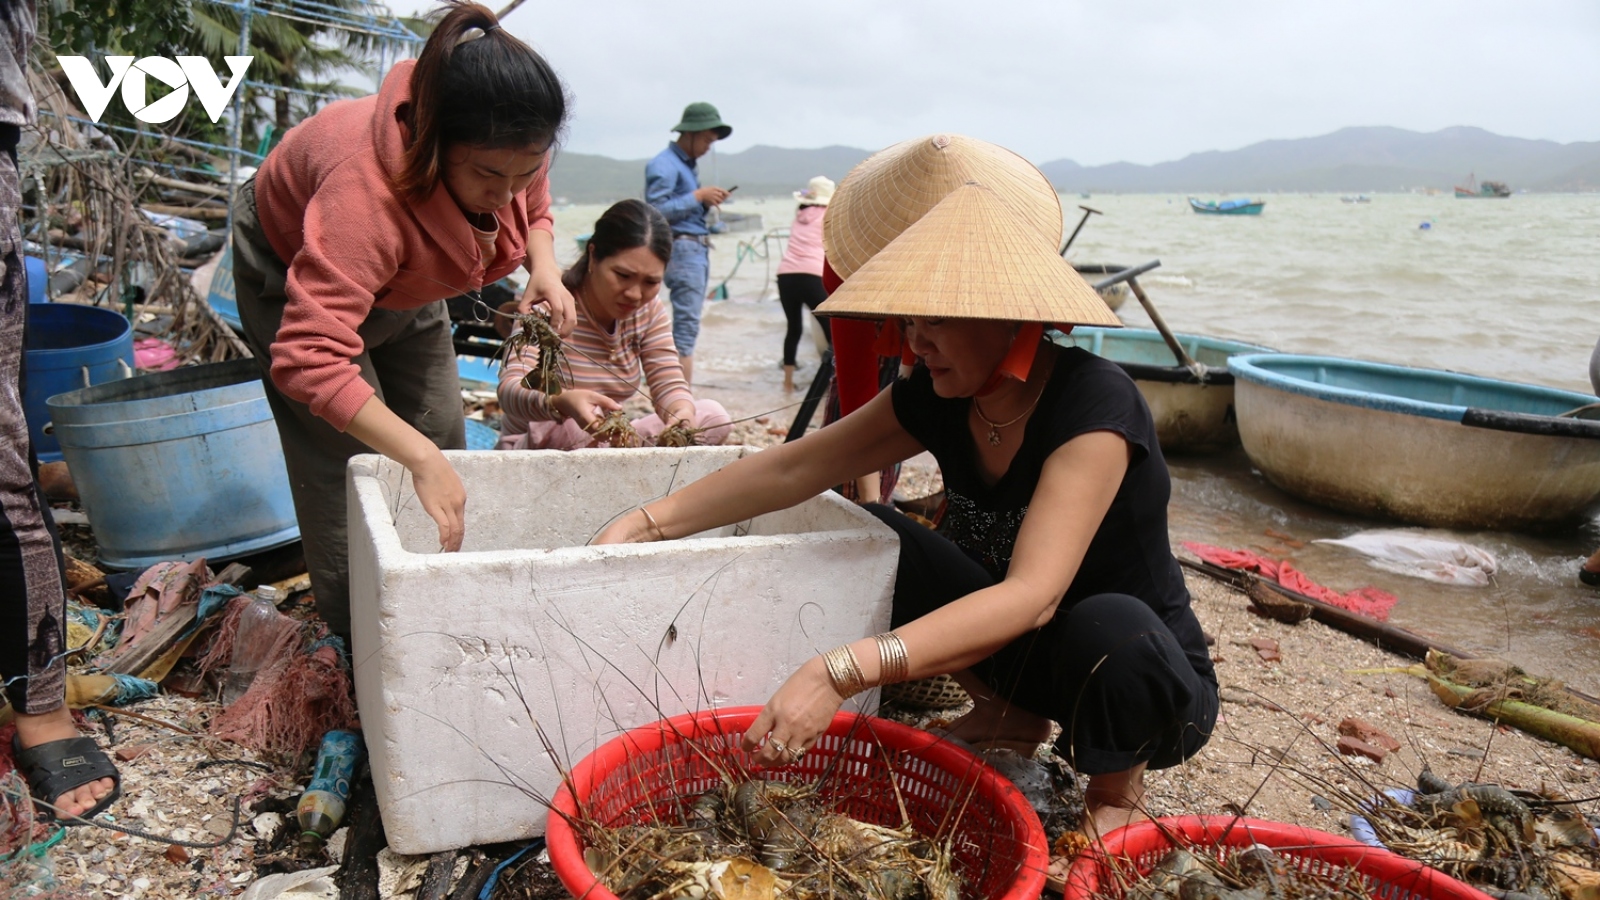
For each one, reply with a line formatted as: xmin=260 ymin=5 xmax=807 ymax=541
xmin=22 ymin=303 xmax=133 ymax=463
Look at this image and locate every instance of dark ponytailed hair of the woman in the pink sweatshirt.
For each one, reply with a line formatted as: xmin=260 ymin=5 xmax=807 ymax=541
xmin=395 ymin=0 xmax=566 ymax=202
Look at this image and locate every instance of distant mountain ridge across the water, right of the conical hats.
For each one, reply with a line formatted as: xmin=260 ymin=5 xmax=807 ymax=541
xmin=1040 ymin=127 xmax=1600 ymax=192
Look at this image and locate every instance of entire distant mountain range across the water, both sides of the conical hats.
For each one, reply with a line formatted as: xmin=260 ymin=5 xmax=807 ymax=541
xmin=550 ymin=127 xmax=1600 ymax=203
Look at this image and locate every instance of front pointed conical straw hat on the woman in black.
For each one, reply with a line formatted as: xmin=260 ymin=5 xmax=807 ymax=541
xmin=816 ymin=184 xmax=1122 ymax=327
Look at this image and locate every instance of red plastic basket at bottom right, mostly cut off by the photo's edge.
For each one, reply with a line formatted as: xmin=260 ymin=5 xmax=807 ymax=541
xmin=1062 ymin=815 xmax=1490 ymax=900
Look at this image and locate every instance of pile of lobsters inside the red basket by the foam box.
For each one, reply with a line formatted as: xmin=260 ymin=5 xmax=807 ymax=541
xmin=584 ymin=780 xmax=960 ymax=900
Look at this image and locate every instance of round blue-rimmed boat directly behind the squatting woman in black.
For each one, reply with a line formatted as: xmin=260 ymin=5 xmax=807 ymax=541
xmin=1051 ymin=328 xmax=1272 ymax=453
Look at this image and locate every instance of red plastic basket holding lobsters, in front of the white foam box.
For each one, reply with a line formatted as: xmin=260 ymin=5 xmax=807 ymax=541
xmin=546 ymin=706 xmax=1050 ymax=900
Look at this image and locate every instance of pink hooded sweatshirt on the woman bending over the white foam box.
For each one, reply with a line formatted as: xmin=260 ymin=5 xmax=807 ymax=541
xmin=256 ymin=59 xmax=552 ymax=431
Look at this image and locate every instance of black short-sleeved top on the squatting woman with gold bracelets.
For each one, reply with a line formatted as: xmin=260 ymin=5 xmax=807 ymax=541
xmin=893 ymin=348 xmax=1214 ymax=677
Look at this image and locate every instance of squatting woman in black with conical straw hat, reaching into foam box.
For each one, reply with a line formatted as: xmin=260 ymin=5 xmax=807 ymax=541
xmin=598 ymin=135 xmax=1218 ymax=833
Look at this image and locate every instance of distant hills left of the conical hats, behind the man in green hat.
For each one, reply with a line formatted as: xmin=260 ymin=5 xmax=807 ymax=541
xmin=550 ymin=144 xmax=872 ymax=203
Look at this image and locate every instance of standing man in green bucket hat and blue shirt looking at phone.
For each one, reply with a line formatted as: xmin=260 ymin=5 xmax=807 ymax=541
xmin=645 ymin=102 xmax=733 ymax=381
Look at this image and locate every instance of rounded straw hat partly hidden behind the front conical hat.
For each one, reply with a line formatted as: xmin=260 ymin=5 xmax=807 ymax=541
xmin=822 ymin=135 xmax=1061 ymax=279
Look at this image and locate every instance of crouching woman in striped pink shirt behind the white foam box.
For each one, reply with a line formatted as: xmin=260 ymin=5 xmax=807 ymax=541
xmin=496 ymin=200 xmax=733 ymax=450
